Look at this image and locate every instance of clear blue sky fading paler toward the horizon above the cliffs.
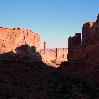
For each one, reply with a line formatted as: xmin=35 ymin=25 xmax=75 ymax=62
xmin=0 ymin=0 xmax=99 ymax=48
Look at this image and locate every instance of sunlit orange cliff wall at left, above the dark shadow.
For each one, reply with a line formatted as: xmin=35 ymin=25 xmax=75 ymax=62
xmin=0 ymin=27 xmax=40 ymax=54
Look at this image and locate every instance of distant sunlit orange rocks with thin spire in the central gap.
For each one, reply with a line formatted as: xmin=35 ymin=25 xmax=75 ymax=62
xmin=40 ymin=42 xmax=68 ymax=67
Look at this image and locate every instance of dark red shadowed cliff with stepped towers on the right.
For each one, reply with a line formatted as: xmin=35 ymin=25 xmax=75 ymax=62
xmin=68 ymin=15 xmax=99 ymax=61
